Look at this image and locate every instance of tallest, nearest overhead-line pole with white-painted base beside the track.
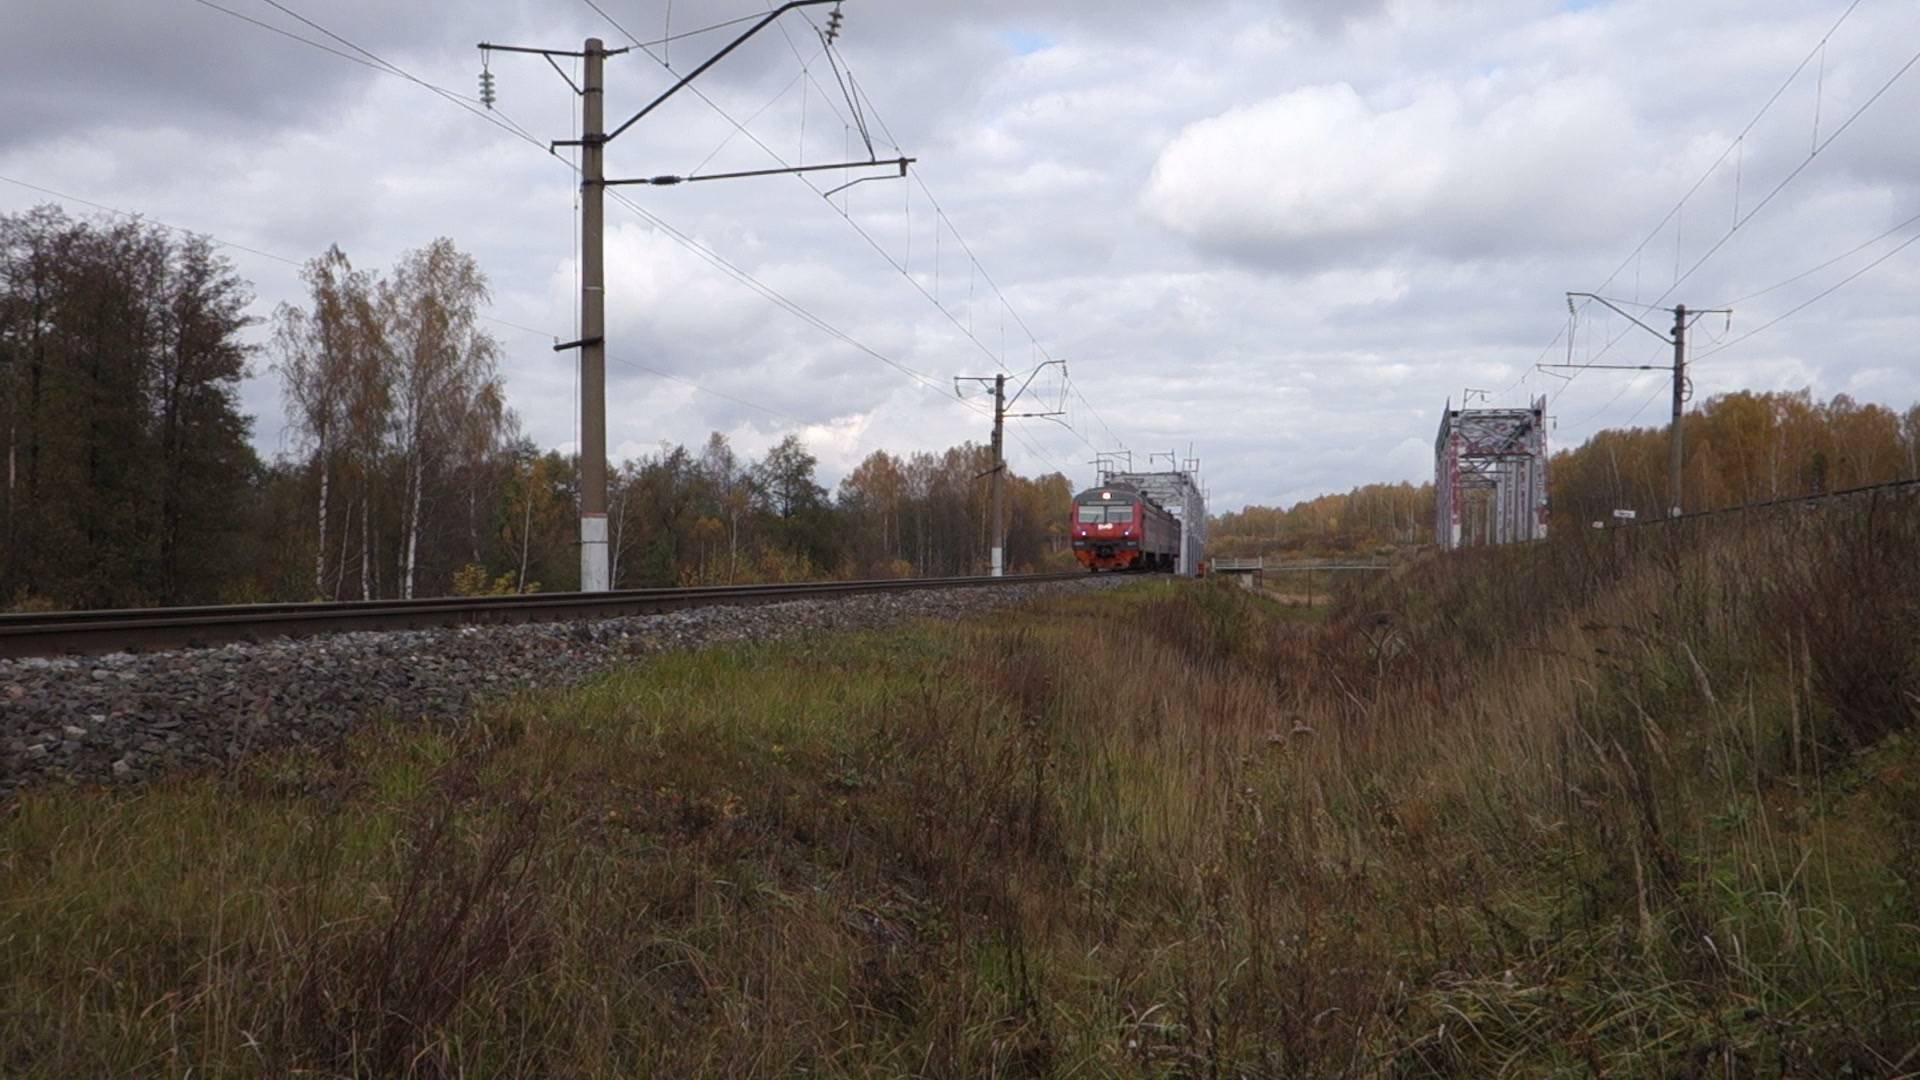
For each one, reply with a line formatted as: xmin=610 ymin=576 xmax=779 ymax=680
xmin=580 ymin=38 xmax=612 ymax=592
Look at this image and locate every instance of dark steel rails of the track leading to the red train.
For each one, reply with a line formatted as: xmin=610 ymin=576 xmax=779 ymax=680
xmin=0 ymin=573 xmax=1087 ymax=659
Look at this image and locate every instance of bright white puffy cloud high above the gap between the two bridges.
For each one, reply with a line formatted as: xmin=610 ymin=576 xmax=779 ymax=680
xmin=1144 ymin=77 xmax=1636 ymax=263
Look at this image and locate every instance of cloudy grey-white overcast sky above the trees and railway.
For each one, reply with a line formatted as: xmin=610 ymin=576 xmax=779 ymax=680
xmin=0 ymin=0 xmax=1920 ymax=511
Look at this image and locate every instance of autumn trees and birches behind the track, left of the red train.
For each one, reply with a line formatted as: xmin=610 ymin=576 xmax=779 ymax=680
xmin=0 ymin=208 xmax=1071 ymax=607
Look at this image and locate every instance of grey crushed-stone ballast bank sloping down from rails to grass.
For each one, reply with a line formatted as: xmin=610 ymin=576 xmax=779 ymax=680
xmin=0 ymin=577 xmax=1123 ymax=799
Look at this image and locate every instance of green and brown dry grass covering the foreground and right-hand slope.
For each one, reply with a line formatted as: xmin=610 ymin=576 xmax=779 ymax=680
xmin=0 ymin=495 xmax=1920 ymax=1076
